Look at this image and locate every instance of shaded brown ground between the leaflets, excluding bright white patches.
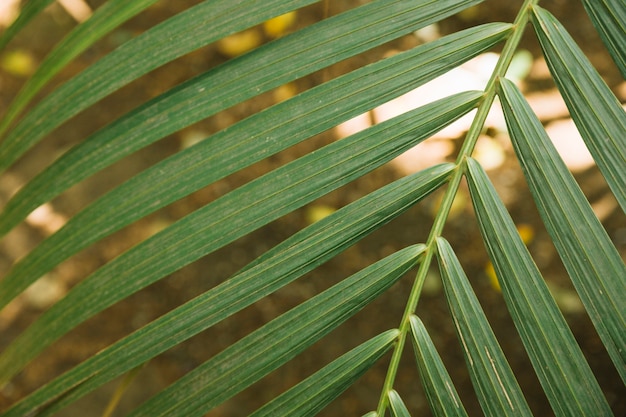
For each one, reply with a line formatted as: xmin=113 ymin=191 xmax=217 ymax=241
xmin=0 ymin=0 xmax=626 ymax=417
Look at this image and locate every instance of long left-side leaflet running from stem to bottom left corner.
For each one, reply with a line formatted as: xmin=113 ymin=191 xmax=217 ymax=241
xmin=5 ymin=164 xmax=438 ymax=417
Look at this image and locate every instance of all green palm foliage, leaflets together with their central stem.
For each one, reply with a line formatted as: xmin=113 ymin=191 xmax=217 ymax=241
xmin=0 ymin=0 xmax=626 ymax=416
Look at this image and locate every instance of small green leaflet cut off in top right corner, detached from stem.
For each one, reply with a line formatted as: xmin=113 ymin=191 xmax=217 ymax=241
xmin=582 ymin=0 xmax=626 ymax=78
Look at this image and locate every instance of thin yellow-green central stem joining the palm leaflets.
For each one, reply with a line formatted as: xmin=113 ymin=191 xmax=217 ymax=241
xmin=376 ymin=0 xmax=539 ymax=417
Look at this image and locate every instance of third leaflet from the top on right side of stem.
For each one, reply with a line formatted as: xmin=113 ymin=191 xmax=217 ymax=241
xmin=467 ymin=158 xmax=612 ymax=416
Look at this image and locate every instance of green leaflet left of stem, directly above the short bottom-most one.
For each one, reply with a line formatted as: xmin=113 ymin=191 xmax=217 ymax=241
xmin=130 ymin=247 xmax=420 ymax=417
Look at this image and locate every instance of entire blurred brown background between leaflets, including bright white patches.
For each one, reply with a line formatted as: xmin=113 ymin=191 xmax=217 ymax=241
xmin=0 ymin=0 xmax=626 ymax=416
